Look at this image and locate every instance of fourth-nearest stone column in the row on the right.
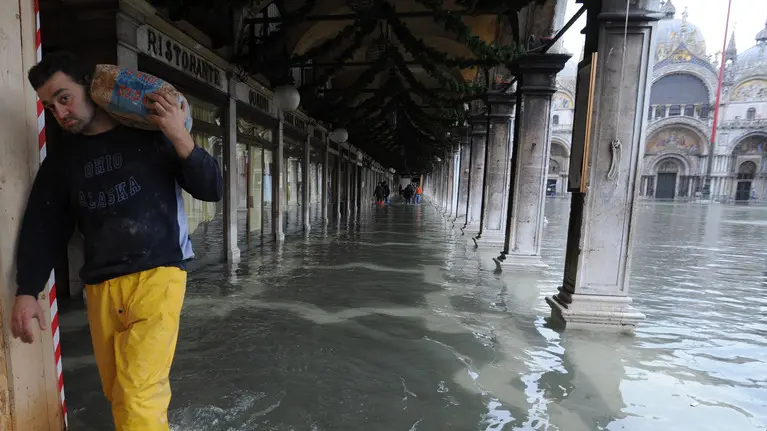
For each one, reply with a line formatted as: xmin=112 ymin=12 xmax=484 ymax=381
xmin=463 ymin=116 xmax=487 ymax=232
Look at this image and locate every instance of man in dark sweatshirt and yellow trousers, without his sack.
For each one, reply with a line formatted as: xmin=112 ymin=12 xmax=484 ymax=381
xmin=11 ymin=53 xmax=223 ymax=431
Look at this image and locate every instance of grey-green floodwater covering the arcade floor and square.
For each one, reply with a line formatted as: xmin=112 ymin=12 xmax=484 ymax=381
xmin=62 ymin=200 xmax=767 ymax=431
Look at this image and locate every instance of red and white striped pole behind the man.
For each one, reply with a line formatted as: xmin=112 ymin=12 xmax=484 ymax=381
xmin=35 ymin=0 xmax=69 ymax=429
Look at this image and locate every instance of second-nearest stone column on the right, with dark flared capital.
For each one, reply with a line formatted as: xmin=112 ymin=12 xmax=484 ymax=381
xmin=495 ymin=54 xmax=570 ymax=268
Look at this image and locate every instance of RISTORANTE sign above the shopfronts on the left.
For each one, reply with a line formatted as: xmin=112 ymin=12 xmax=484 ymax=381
xmin=137 ymin=25 xmax=228 ymax=92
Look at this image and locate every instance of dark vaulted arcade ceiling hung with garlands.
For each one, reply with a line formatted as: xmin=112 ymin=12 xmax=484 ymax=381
xmin=153 ymin=0 xmax=564 ymax=172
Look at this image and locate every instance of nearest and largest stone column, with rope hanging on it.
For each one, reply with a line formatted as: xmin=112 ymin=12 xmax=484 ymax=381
xmin=546 ymin=0 xmax=662 ymax=331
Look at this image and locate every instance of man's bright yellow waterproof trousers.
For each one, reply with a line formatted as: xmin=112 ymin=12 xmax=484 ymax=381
xmin=86 ymin=267 xmax=186 ymax=431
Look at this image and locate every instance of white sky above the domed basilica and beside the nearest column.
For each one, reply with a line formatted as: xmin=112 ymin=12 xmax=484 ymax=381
xmin=564 ymin=0 xmax=767 ymax=58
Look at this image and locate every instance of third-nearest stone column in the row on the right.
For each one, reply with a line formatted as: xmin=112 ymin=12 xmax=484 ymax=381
xmin=474 ymin=93 xmax=514 ymax=246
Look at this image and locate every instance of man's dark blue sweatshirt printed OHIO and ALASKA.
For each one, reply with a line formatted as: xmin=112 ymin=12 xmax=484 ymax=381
xmin=16 ymin=126 xmax=223 ymax=295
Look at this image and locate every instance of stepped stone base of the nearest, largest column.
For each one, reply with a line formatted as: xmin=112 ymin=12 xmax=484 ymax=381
xmin=546 ymin=294 xmax=645 ymax=333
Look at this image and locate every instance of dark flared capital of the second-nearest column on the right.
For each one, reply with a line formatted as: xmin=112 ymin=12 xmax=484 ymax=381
xmin=509 ymin=53 xmax=571 ymax=95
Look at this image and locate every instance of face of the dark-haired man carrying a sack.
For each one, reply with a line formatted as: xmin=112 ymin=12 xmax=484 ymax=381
xmin=37 ymin=72 xmax=94 ymax=133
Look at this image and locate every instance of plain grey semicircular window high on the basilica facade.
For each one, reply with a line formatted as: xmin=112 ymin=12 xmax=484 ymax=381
xmin=650 ymin=73 xmax=711 ymax=105
